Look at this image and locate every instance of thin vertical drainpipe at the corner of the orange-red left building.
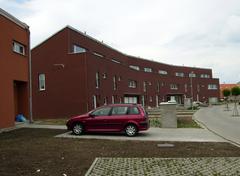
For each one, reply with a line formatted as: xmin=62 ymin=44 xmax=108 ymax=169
xmin=28 ymin=28 xmax=33 ymax=123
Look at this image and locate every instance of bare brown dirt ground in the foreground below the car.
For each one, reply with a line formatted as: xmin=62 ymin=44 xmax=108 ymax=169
xmin=0 ymin=129 xmax=240 ymax=176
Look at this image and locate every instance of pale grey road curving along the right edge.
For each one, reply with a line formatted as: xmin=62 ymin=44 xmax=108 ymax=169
xmin=194 ymin=104 xmax=240 ymax=146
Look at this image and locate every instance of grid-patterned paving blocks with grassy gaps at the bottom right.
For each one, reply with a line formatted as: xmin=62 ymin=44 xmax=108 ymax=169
xmin=86 ymin=157 xmax=240 ymax=176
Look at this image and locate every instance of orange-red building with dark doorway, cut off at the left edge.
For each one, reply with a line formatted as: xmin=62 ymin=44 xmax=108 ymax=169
xmin=0 ymin=8 xmax=30 ymax=128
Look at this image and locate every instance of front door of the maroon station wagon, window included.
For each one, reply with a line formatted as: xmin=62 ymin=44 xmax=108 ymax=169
xmin=85 ymin=107 xmax=111 ymax=131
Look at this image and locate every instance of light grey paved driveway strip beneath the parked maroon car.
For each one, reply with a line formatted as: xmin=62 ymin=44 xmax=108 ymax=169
xmin=57 ymin=128 xmax=226 ymax=142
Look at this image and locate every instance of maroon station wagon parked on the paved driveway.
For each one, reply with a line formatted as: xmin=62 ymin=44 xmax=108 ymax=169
xmin=66 ymin=104 xmax=149 ymax=136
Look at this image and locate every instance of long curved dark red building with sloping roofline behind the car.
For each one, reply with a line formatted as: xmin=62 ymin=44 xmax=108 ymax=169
xmin=32 ymin=26 xmax=219 ymax=118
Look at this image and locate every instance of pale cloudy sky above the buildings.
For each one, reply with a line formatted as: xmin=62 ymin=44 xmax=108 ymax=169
xmin=0 ymin=0 xmax=240 ymax=83
